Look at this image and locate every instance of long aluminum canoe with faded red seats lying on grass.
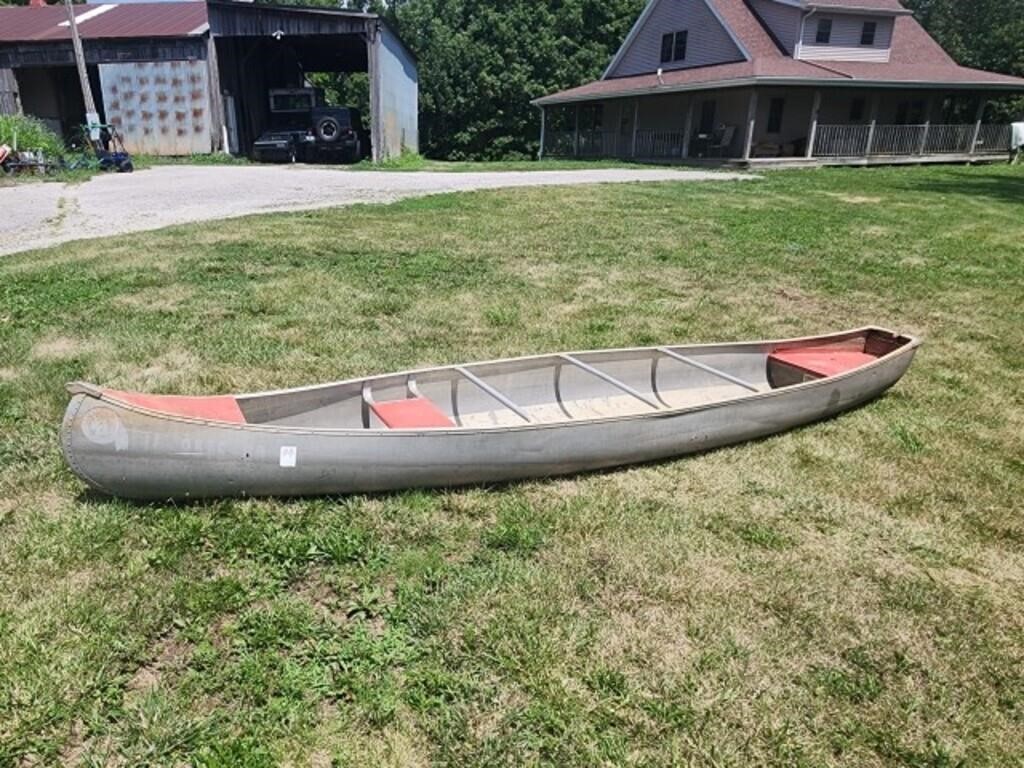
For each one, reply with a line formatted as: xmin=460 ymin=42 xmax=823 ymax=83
xmin=61 ymin=327 xmax=921 ymax=500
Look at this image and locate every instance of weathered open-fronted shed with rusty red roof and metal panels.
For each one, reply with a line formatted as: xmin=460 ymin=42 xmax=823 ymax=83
xmin=0 ymin=0 xmax=419 ymax=159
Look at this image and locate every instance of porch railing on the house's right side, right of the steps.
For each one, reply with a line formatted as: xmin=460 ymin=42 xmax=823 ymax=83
xmin=813 ymin=124 xmax=1011 ymax=158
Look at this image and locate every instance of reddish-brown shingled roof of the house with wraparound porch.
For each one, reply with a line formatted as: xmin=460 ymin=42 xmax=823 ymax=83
xmin=535 ymin=0 xmax=1024 ymax=104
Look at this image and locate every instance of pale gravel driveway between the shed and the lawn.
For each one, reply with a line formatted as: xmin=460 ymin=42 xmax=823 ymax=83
xmin=0 ymin=166 xmax=750 ymax=254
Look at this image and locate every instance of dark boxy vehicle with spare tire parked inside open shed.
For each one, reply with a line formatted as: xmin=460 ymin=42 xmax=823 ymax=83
xmin=253 ymin=88 xmax=370 ymax=163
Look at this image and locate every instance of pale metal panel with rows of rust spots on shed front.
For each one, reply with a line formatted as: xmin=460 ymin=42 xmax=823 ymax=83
xmin=99 ymin=60 xmax=213 ymax=155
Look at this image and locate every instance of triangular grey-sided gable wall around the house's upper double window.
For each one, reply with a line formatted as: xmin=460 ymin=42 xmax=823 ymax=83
xmin=608 ymin=0 xmax=743 ymax=78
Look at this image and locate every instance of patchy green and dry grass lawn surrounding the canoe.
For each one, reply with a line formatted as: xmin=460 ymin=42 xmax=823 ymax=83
xmin=0 ymin=167 xmax=1024 ymax=767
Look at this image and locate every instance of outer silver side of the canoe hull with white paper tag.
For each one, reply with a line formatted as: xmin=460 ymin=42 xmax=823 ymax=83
xmin=61 ymin=335 xmax=916 ymax=500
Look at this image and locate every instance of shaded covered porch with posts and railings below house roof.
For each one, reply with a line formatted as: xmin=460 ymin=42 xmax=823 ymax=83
xmin=541 ymin=86 xmax=1012 ymax=166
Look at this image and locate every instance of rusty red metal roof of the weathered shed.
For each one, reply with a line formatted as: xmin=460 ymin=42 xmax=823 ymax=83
xmin=0 ymin=2 xmax=208 ymax=43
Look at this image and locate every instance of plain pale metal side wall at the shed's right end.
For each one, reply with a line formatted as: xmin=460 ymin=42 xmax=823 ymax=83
xmin=370 ymin=25 xmax=420 ymax=160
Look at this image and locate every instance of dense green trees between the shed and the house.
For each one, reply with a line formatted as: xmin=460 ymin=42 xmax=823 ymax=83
xmin=393 ymin=0 xmax=643 ymax=159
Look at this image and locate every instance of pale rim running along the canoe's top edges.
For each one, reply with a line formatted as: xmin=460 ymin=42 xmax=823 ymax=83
xmin=63 ymin=326 xmax=922 ymax=442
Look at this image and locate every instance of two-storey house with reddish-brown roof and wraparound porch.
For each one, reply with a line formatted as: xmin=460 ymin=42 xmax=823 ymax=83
xmin=534 ymin=0 xmax=1024 ymax=165
